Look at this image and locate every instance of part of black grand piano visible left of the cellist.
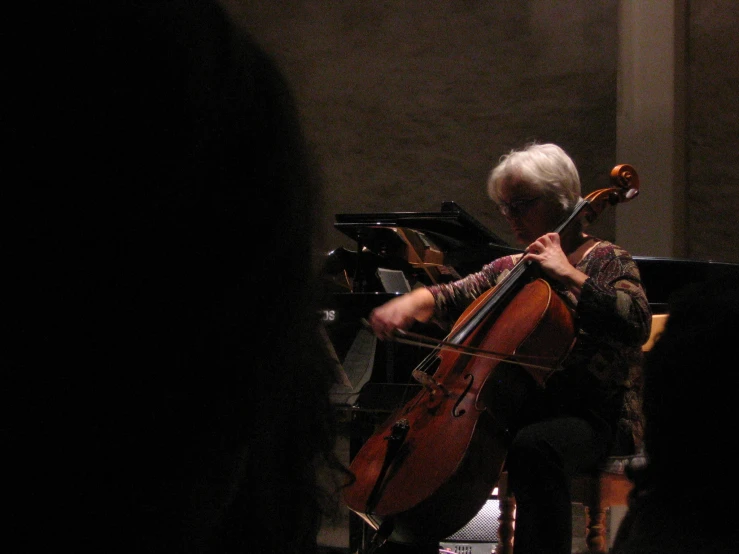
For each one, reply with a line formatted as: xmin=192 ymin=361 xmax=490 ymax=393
xmin=323 ymin=202 xmax=518 ymax=409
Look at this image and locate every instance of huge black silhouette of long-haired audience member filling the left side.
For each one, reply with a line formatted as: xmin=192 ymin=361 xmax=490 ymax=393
xmin=6 ymin=0 xmax=340 ymax=553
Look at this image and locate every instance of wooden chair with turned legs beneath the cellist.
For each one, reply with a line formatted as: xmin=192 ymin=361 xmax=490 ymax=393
xmin=495 ymin=314 xmax=667 ymax=554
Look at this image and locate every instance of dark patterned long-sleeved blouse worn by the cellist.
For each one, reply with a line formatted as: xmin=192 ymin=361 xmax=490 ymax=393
xmin=429 ymin=241 xmax=651 ymax=454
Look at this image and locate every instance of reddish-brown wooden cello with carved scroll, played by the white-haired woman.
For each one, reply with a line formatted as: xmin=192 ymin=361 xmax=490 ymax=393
xmin=343 ymin=164 xmax=639 ymax=548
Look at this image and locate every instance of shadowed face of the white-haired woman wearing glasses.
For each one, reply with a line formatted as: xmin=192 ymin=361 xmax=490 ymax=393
xmin=498 ymin=178 xmax=562 ymax=246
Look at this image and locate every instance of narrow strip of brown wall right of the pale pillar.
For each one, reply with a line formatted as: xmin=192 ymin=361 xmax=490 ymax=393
xmin=686 ymin=0 xmax=739 ymax=262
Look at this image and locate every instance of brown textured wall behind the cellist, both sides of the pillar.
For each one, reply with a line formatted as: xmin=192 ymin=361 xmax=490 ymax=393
xmin=222 ymin=0 xmax=739 ymax=262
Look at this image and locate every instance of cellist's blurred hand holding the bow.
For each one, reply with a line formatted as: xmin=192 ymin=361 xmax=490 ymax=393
xmin=369 ymin=288 xmax=435 ymax=340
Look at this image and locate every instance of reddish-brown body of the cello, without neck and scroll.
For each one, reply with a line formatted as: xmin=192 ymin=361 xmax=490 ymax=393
xmin=344 ymin=279 xmax=575 ymax=544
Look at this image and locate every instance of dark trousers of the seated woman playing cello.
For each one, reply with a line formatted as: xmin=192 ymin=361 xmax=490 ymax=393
xmin=506 ymin=416 xmax=611 ymax=554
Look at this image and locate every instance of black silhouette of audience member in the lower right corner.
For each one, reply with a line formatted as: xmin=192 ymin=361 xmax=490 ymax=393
xmin=613 ymin=275 xmax=739 ymax=554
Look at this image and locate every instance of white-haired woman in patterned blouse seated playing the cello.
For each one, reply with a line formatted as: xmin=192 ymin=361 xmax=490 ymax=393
xmin=369 ymin=144 xmax=651 ymax=554
